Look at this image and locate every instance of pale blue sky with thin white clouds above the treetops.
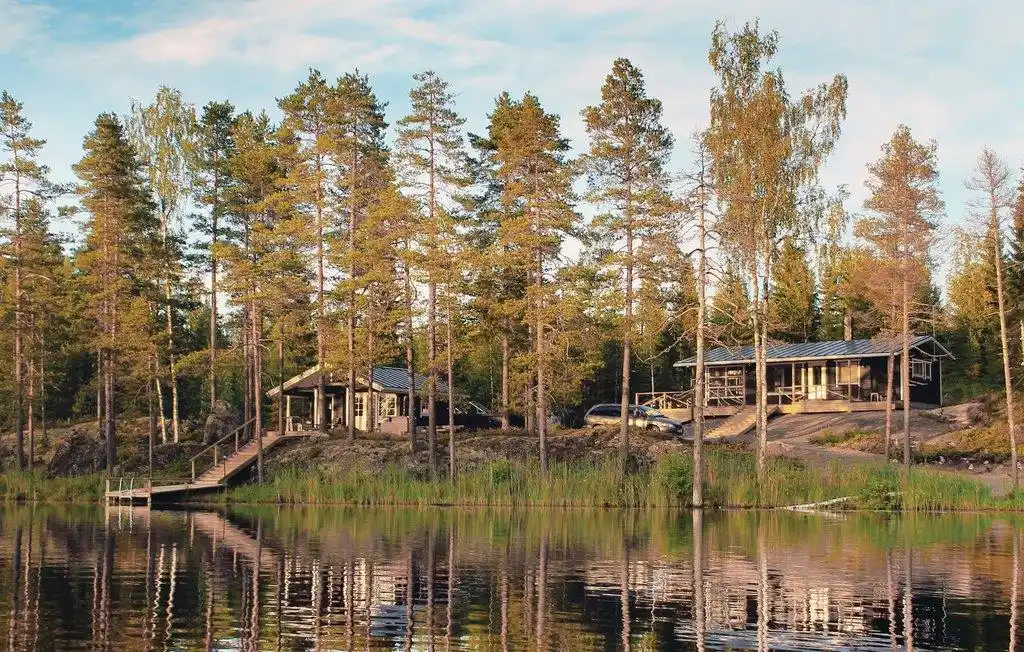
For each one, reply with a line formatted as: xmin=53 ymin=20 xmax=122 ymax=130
xmin=0 ymin=0 xmax=1024 ymax=264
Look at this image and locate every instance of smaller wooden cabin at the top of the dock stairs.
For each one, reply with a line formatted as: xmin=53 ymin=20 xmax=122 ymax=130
xmin=267 ymin=366 xmax=447 ymax=433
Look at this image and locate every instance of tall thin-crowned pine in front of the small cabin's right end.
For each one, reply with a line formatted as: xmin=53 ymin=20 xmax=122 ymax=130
xmin=395 ymin=71 xmax=467 ymax=474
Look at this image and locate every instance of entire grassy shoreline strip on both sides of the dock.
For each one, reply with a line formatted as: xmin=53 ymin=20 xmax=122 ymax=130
xmin=0 ymin=447 xmax=1024 ymax=513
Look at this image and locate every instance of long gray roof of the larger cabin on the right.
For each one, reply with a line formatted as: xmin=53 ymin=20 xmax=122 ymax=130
xmin=675 ymin=335 xmax=952 ymax=366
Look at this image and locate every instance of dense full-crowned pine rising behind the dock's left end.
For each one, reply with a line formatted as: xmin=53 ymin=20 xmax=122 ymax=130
xmin=74 ymin=114 xmax=161 ymax=473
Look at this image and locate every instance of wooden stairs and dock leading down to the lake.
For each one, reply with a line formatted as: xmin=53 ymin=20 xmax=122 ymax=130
xmin=103 ymin=430 xmax=314 ymax=504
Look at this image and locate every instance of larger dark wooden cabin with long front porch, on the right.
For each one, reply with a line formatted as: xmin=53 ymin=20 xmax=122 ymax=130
xmin=675 ymin=335 xmax=952 ymax=411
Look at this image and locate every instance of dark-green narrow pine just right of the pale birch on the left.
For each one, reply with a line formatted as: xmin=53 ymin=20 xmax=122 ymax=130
xmin=196 ymin=101 xmax=234 ymax=409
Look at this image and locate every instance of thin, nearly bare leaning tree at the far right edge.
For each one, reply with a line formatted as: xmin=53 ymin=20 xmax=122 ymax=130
xmin=966 ymin=147 xmax=1020 ymax=483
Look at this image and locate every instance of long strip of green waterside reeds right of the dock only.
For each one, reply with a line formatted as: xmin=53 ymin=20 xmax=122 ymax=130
xmin=216 ymin=450 xmax=1024 ymax=511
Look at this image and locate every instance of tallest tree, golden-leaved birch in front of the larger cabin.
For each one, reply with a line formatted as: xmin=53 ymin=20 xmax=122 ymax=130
xmin=708 ymin=21 xmax=847 ymax=481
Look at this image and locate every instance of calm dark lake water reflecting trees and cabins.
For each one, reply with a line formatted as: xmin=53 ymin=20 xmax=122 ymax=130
xmin=0 ymin=507 xmax=1024 ymax=650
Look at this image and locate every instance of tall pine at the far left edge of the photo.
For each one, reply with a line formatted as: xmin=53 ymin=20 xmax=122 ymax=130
xmin=0 ymin=91 xmax=57 ymax=471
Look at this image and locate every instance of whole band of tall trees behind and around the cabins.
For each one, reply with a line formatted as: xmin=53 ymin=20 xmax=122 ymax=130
xmin=0 ymin=21 xmax=1024 ymax=469
